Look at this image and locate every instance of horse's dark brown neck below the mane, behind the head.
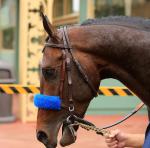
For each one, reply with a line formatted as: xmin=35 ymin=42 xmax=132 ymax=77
xmin=71 ymin=25 xmax=150 ymax=105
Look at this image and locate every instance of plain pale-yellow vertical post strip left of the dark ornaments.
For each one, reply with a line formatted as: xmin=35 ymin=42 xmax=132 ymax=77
xmin=19 ymin=0 xmax=28 ymax=122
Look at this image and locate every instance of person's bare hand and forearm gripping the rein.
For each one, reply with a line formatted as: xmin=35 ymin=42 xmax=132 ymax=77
xmin=105 ymin=130 xmax=145 ymax=148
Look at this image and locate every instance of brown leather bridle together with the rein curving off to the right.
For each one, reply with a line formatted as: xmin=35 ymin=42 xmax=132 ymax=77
xmin=36 ymin=26 xmax=144 ymax=137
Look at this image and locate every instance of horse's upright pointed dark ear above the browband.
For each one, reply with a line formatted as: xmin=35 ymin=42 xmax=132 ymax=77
xmin=41 ymin=12 xmax=58 ymax=40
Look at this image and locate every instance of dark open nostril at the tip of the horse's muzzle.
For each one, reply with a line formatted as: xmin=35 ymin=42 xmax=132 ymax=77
xmin=37 ymin=131 xmax=48 ymax=144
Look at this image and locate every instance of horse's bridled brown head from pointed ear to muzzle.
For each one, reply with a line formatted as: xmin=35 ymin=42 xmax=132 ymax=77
xmin=36 ymin=14 xmax=100 ymax=148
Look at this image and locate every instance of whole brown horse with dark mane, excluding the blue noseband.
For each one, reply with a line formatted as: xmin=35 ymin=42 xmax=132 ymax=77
xmin=37 ymin=17 xmax=150 ymax=148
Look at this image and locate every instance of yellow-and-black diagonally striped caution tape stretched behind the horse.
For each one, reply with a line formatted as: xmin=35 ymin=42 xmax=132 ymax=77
xmin=0 ymin=84 xmax=134 ymax=96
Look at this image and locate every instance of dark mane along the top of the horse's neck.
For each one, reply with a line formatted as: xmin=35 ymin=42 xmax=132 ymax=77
xmin=81 ymin=16 xmax=150 ymax=31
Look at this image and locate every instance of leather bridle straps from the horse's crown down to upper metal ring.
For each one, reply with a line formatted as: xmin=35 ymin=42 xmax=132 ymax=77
xmin=44 ymin=26 xmax=98 ymax=113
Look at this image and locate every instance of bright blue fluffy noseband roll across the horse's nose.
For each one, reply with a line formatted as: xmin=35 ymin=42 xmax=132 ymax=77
xmin=34 ymin=94 xmax=61 ymax=110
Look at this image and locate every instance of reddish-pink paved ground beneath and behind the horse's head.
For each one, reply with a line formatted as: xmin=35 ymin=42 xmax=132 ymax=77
xmin=0 ymin=115 xmax=148 ymax=148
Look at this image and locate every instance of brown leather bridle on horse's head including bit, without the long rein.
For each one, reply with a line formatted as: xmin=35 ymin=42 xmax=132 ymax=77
xmin=44 ymin=26 xmax=102 ymax=141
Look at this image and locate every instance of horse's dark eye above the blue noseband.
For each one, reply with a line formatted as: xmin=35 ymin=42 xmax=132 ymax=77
xmin=42 ymin=68 xmax=57 ymax=80
